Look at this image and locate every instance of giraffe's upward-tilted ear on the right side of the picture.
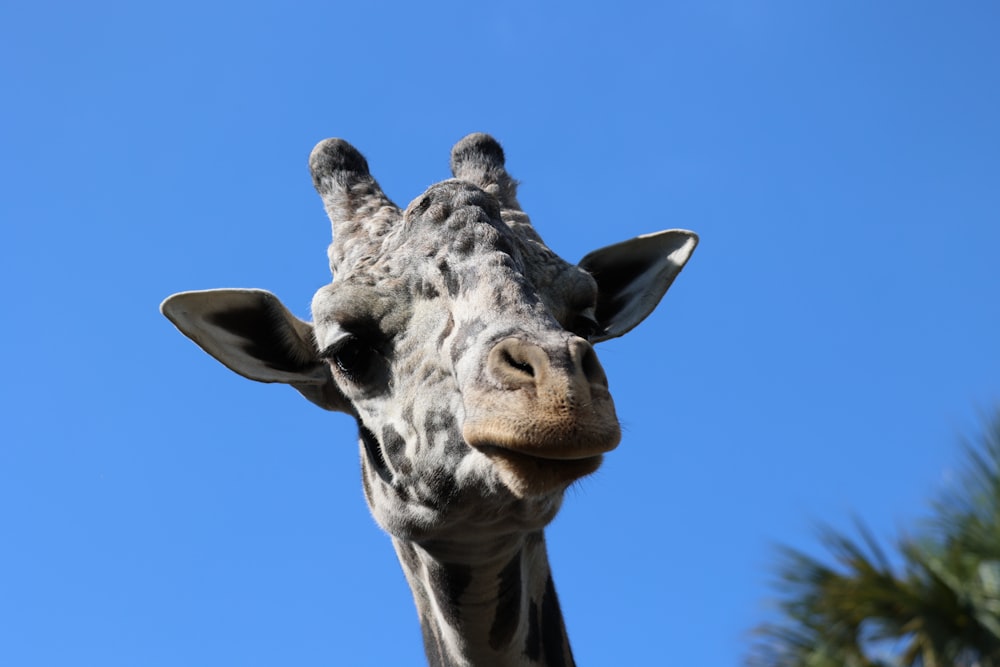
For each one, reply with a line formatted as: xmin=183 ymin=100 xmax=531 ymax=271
xmin=580 ymin=229 xmax=698 ymax=343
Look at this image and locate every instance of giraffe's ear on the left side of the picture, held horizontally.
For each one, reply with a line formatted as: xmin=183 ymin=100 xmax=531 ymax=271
xmin=160 ymin=289 xmax=353 ymax=413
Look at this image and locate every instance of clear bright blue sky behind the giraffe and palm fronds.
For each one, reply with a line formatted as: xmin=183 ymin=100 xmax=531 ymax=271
xmin=0 ymin=0 xmax=1000 ymax=667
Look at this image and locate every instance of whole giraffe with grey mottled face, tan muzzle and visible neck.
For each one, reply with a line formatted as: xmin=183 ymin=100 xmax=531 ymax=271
xmin=161 ymin=134 xmax=698 ymax=666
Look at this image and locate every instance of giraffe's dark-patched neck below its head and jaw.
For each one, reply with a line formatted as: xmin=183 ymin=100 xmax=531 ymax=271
xmin=393 ymin=531 xmax=575 ymax=667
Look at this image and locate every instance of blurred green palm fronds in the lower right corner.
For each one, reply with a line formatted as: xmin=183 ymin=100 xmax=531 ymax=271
xmin=746 ymin=411 xmax=1000 ymax=667
